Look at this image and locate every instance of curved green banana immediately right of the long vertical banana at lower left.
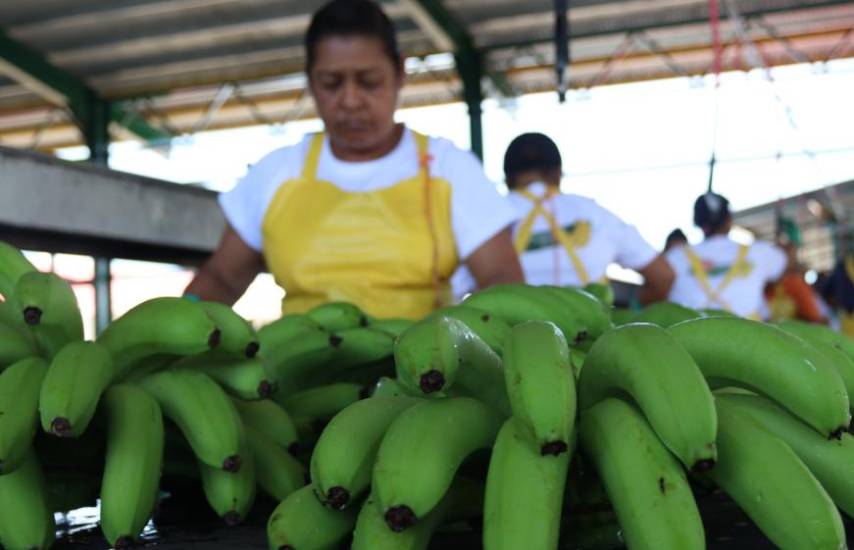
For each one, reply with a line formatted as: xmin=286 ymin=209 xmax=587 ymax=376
xmin=138 ymin=369 xmax=243 ymax=472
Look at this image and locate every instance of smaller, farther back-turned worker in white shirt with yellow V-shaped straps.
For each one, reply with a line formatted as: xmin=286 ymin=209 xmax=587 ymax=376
xmin=666 ymin=192 xmax=786 ymax=319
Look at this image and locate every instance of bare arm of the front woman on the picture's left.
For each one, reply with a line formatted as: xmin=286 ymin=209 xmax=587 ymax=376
xmin=185 ymin=225 xmax=264 ymax=305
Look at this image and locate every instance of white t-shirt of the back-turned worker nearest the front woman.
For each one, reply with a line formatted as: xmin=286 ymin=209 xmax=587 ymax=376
xmin=452 ymin=183 xmax=658 ymax=296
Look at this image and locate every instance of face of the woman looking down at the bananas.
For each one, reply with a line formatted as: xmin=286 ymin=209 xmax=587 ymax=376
xmin=308 ymin=35 xmax=403 ymax=155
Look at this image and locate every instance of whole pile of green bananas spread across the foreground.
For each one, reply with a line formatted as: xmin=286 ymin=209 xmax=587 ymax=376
xmin=5 ymin=239 xmax=854 ymax=550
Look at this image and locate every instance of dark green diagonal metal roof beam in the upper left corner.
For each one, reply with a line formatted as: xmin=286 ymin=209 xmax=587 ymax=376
xmin=0 ymin=30 xmax=171 ymax=147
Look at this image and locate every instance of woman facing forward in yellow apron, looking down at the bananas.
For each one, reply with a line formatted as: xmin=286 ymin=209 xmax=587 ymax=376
xmin=187 ymin=0 xmax=523 ymax=318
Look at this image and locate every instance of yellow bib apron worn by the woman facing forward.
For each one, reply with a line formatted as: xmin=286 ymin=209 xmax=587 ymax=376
xmin=262 ymin=132 xmax=459 ymax=319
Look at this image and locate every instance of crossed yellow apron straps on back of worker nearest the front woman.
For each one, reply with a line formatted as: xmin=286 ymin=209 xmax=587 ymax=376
xmin=514 ymin=186 xmax=607 ymax=286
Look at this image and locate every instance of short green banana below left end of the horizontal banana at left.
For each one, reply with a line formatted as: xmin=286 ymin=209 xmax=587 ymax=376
xmin=39 ymin=341 xmax=114 ymax=437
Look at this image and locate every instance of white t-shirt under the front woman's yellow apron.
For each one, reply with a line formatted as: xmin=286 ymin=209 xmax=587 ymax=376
xmin=219 ymin=129 xmax=516 ymax=261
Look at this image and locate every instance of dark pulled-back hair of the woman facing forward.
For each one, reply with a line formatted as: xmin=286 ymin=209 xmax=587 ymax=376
xmin=305 ymin=0 xmax=400 ymax=73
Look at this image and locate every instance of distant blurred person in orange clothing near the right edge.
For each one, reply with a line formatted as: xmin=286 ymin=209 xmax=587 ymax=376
xmin=765 ymin=218 xmax=828 ymax=324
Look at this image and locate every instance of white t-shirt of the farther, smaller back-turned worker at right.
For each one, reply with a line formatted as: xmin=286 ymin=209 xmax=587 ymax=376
xmin=667 ymin=235 xmax=787 ymax=317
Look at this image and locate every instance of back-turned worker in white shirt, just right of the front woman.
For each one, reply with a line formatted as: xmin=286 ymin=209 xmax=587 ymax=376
xmin=458 ymin=133 xmax=674 ymax=303
